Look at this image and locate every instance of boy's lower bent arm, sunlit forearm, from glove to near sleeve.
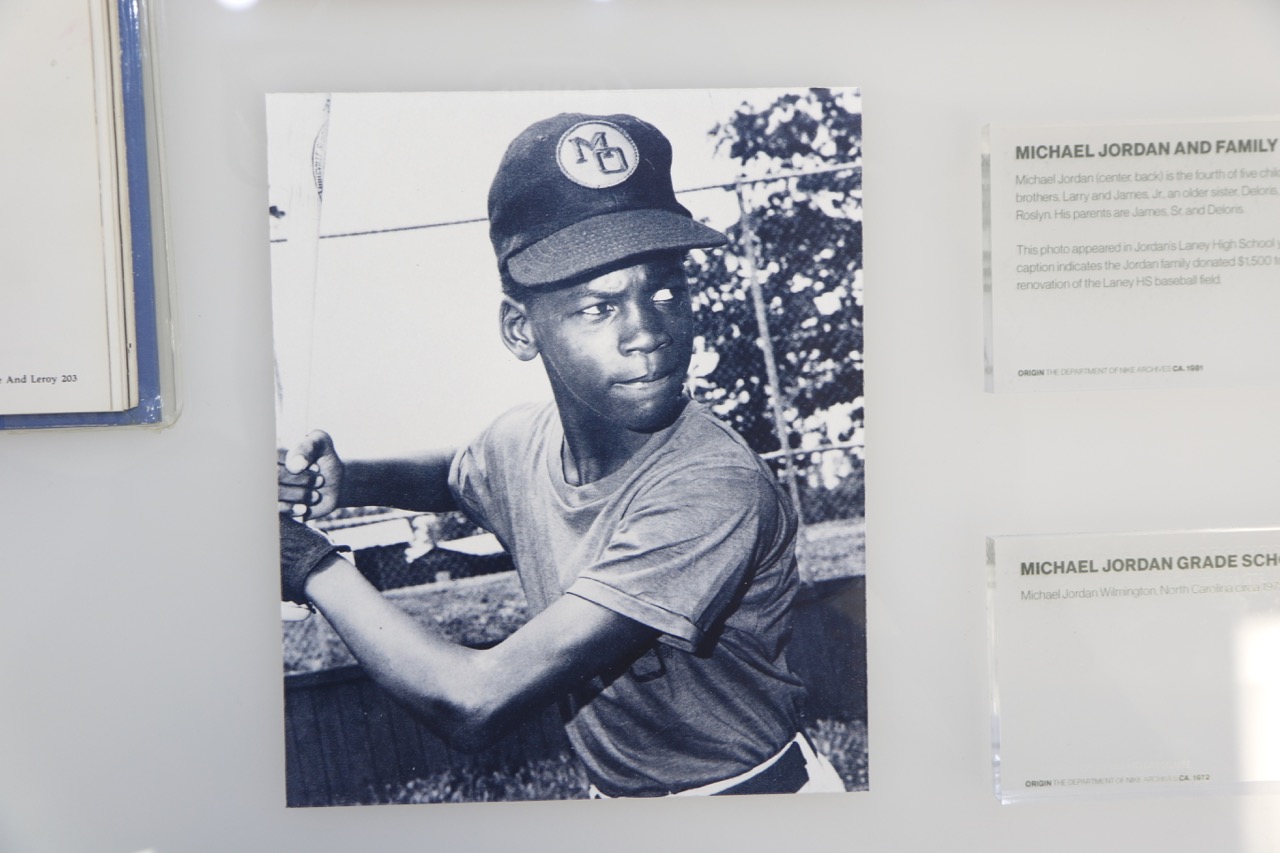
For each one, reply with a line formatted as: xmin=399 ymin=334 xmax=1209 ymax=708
xmin=305 ymin=540 xmax=657 ymax=751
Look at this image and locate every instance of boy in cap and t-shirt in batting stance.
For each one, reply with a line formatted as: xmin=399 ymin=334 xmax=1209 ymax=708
xmin=280 ymin=114 xmax=844 ymax=797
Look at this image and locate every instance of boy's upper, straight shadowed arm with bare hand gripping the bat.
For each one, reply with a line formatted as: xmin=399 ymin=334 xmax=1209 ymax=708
xmin=278 ymin=429 xmax=457 ymax=519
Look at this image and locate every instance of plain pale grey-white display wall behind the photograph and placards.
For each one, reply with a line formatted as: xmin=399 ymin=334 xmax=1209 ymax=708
xmin=0 ymin=0 xmax=1280 ymax=853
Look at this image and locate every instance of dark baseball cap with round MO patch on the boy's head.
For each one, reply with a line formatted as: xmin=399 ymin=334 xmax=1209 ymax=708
xmin=489 ymin=113 xmax=728 ymax=287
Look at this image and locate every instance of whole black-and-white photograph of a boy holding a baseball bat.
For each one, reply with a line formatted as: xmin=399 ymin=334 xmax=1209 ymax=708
xmin=264 ymin=88 xmax=869 ymax=807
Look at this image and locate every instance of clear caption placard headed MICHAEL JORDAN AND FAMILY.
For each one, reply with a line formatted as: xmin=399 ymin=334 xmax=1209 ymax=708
xmin=987 ymin=119 xmax=1280 ymax=391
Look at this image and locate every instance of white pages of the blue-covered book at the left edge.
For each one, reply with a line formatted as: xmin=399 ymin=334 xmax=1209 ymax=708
xmin=0 ymin=0 xmax=136 ymax=415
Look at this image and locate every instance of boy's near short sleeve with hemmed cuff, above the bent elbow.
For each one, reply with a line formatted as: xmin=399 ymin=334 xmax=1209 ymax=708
xmin=567 ymin=466 xmax=778 ymax=651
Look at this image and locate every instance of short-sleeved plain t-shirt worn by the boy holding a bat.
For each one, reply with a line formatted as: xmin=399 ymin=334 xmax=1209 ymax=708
xmin=449 ymin=403 xmax=804 ymax=797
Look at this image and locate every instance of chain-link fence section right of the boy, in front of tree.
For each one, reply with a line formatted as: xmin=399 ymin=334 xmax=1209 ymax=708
xmin=682 ymin=164 xmax=864 ymax=525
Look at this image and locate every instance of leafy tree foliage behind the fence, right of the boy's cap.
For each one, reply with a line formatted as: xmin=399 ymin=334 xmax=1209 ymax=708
xmin=690 ymin=88 xmax=863 ymax=468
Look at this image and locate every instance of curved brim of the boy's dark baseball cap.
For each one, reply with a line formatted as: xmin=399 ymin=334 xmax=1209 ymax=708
xmin=507 ymin=210 xmax=728 ymax=287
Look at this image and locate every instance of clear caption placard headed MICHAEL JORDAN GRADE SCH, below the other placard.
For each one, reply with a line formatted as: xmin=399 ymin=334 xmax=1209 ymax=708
xmin=988 ymin=529 xmax=1280 ymax=800
